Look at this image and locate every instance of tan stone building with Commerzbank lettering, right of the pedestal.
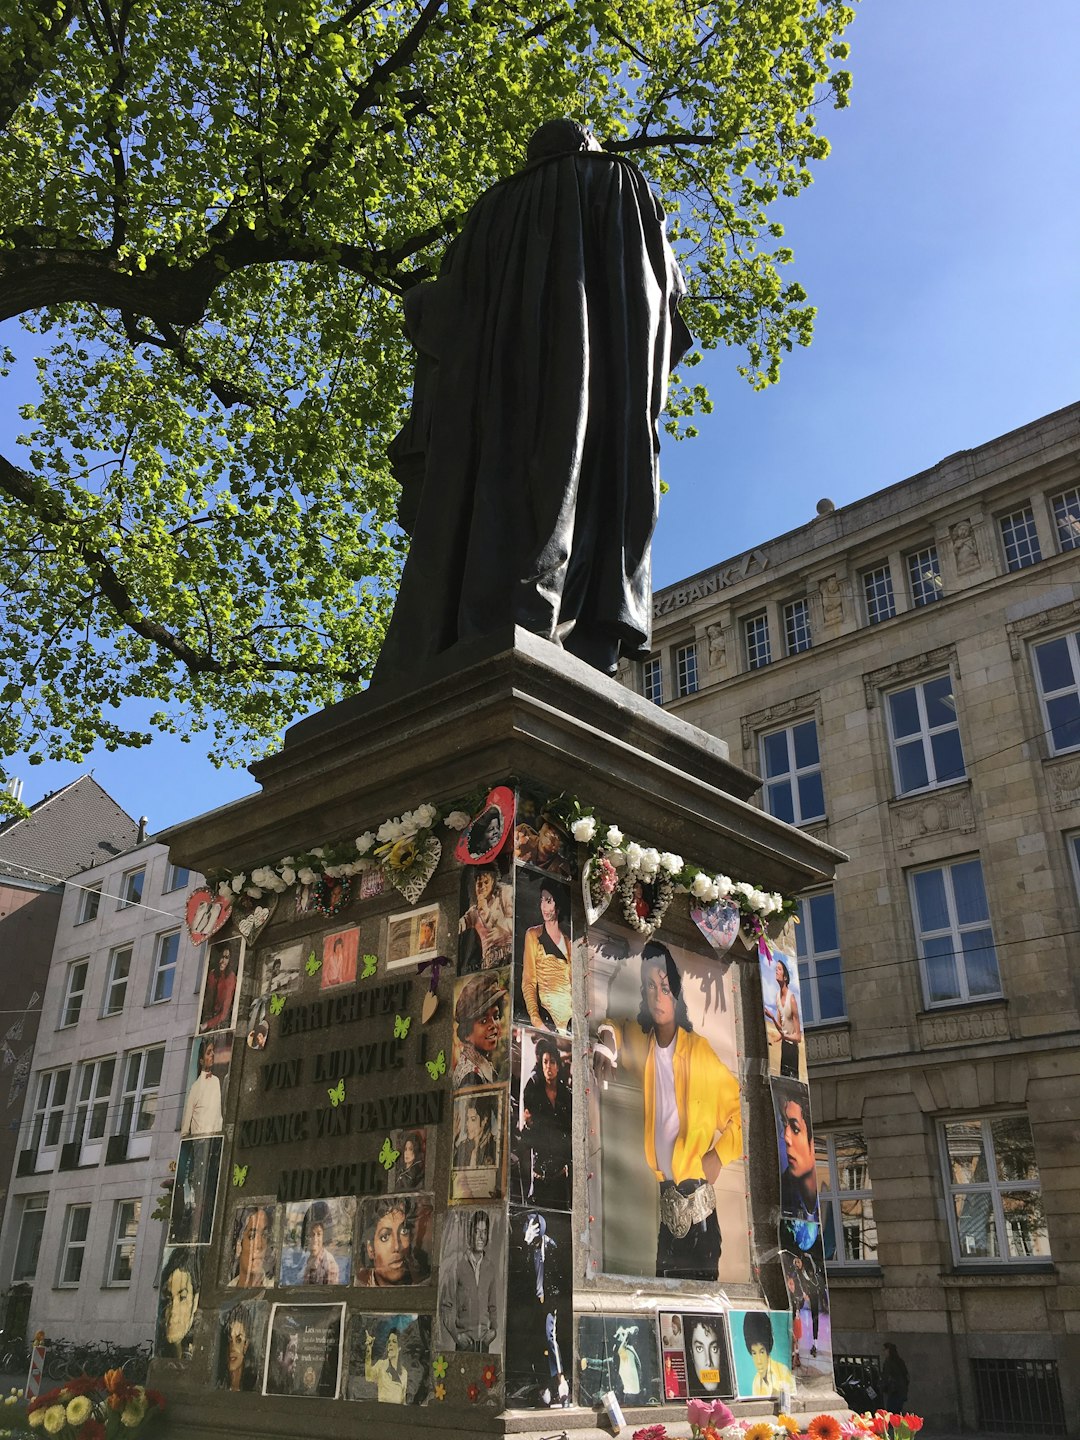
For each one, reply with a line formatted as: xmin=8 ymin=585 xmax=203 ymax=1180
xmin=639 ymin=405 xmax=1080 ymax=1434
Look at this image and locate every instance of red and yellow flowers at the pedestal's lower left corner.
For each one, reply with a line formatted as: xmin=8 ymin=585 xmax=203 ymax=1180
xmin=0 ymin=1369 xmax=166 ymax=1440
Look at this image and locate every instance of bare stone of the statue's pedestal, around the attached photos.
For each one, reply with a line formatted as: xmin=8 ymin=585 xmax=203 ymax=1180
xmin=158 ymin=631 xmax=844 ymax=1440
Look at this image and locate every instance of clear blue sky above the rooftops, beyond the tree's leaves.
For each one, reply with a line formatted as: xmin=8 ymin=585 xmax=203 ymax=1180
xmin=0 ymin=0 xmax=1080 ymax=829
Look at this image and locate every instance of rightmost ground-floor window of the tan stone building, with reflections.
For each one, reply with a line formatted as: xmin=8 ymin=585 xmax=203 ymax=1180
xmin=942 ymin=1115 xmax=1050 ymax=1264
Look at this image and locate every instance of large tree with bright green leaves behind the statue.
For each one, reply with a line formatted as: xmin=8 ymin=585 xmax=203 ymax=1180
xmin=0 ymin=0 xmax=852 ymax=800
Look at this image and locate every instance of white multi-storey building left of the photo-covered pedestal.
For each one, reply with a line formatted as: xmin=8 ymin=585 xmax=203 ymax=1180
xmin=0 ymin=840 xmax=202 ymax=1345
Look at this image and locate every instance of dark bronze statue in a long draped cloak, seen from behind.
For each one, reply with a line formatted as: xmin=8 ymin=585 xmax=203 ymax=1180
xmin=374 ymin=120 xmax=691 ymax=681
